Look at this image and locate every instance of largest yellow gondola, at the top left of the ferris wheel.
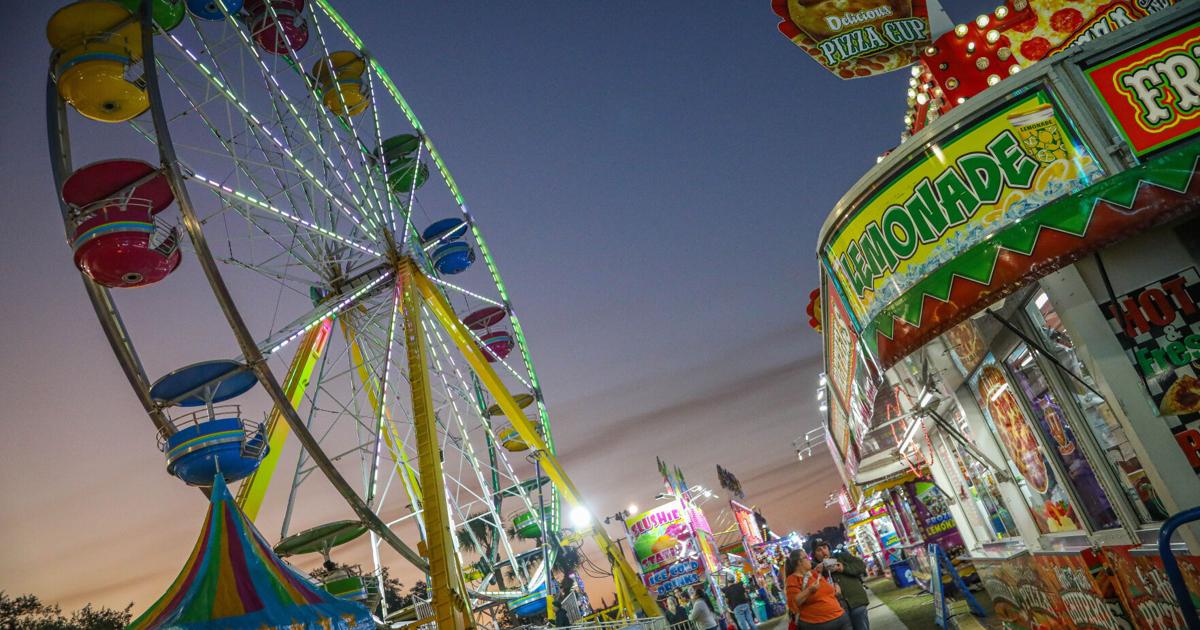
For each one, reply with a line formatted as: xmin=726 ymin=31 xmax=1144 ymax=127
xmin=46 ymin=0 xmax=150 ymax=122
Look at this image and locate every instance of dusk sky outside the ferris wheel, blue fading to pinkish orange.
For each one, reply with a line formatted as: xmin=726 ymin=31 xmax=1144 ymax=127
xmin=0 ymin=0 xmax=992 ymax=612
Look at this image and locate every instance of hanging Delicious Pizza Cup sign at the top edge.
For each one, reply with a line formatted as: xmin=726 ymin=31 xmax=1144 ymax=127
xmin=772 ymin=0 xmax=930 ymax=79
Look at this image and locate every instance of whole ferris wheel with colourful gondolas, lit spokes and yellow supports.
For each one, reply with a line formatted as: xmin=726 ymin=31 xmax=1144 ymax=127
xmin=47 ymin=0 xmax=624 ymax=619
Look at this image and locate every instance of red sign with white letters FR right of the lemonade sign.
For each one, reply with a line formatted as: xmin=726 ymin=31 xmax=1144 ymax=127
xmin=1086 ymin=16 xmax=1200 ymax=156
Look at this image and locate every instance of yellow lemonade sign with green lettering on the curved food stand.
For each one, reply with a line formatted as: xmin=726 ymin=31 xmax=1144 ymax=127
xmin=822 ymin=91 xmax=1103 ymax=328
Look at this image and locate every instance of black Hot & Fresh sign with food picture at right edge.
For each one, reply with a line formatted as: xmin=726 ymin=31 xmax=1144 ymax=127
xmin=1100 ymin=266 xmax=1200 ymax=472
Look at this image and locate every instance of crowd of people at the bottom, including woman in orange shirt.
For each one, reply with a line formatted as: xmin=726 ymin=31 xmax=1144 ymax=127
xmin=662 ymin=540 xmax=870 ymax=630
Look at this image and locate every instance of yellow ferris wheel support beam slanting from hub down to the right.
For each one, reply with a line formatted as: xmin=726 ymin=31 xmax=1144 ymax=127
xmin=401 ymin=258 xmax=661 ymax=617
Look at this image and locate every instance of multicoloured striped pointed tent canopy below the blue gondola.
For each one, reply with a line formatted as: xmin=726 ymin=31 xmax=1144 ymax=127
xmin=128 ymin=475 xmax=374 ymax=630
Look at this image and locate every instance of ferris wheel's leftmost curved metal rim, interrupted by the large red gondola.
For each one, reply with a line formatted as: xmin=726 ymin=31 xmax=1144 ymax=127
xmin=46 ymin=78 xmax=175 ymax=437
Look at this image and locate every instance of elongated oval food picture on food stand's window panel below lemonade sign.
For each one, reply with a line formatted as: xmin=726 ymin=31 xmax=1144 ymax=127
xmin=976 ymin=365 xmax=1050 ymax=494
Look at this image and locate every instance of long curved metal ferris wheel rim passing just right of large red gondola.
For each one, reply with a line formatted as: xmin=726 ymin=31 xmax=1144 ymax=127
xmin=142 ymin=0 xmax=428 ymax=570
